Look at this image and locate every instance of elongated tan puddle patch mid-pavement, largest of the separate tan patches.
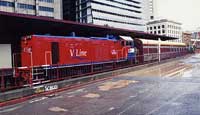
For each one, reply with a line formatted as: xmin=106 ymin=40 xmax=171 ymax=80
xmin=99 ymin=80 xmax=138 ymax=91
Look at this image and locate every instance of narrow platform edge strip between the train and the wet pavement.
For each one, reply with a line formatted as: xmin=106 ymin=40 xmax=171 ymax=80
xmin=0 ymin=57 xmax=174 ymax=102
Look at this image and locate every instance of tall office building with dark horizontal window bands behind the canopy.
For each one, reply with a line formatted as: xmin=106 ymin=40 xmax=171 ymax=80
xmin=67 ymin=0 xmax=149 ymax=31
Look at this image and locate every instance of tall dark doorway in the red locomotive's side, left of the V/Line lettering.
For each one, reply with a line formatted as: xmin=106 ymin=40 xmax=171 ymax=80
xmin=51 ymin=42 xmax=60 ymax=64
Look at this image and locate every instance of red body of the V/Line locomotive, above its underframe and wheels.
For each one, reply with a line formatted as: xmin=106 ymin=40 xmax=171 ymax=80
xmin=21 ymin=35 xmax=133 ymax=67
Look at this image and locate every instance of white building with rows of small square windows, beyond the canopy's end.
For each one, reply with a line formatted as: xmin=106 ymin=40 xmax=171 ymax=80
xmin=147 ymin=19 xmax=182 ymax=42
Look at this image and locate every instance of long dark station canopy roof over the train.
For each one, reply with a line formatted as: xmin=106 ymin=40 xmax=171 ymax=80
xmin=0 ymin=12 xmax=177 ymax=43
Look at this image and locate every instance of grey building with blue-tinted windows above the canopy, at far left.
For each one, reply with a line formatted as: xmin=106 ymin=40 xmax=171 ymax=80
xmin=0 ymin=0 xmax=62 ymax=19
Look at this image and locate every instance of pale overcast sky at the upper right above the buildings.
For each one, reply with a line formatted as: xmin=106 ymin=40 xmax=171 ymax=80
xmin=155 ymin=0 xmax=200 ymax=30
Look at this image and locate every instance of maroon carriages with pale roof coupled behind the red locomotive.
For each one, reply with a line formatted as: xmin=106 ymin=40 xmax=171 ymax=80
xmin=134 ymin=38 xmax=188 ymax=63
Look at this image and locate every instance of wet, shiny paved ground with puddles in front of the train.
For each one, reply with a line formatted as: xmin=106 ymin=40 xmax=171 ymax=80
xmin=0 ymin=55 xmax=200 ymax=115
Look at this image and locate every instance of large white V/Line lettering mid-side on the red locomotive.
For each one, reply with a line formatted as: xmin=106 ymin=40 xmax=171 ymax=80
xmin=70 ymin=49 xmax=87 ymax=57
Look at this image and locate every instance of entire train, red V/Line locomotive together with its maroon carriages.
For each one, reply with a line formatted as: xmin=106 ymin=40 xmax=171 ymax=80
xmin=12 ymin=35 xmax=187 ymax=83
